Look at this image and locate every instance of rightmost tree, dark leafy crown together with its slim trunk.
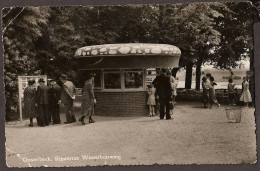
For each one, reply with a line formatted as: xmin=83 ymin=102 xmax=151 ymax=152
xmin=196 ymin=2 xmax=253 ymax=90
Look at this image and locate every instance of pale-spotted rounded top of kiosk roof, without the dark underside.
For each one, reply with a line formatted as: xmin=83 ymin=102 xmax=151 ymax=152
xmin=75 ymin=43 xmax=181 ymax=58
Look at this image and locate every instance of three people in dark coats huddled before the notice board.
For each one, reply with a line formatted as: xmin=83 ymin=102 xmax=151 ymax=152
xmin=23 ymin=78 xmax=61 ymax=127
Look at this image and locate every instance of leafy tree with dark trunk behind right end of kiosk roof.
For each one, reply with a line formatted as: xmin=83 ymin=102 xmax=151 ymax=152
xmin=132 ymin=2 xmax=226 ymax=88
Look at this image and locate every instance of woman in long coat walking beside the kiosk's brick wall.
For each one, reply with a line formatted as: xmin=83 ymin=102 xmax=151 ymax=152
xmin=79 ymin=74 xmax=96 ymax=125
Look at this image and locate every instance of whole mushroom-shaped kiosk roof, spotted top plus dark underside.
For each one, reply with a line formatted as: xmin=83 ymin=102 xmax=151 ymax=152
xmin=75 ymin=43 xmax=181 ymax=70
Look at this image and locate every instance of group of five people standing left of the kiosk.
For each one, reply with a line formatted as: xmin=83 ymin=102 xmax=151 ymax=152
xmin=23 ymin=74 xmax=96 ymax=127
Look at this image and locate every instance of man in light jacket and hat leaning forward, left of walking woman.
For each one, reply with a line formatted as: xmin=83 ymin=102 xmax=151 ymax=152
xmin=60 ymin=74 xmax=77 ymax=124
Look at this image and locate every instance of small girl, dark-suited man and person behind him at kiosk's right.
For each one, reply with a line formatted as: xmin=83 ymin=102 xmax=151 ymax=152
xmin=147 ymin=68 xmax=177 ymax=120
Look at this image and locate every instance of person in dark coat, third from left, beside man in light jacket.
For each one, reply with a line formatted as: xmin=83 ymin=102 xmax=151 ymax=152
xmin=49 ymin=80 xmax=61 ymax=124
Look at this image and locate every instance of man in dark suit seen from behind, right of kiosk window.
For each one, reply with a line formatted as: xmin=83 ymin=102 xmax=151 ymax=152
xmin=152 ymin=68 xmax=172 ymax=120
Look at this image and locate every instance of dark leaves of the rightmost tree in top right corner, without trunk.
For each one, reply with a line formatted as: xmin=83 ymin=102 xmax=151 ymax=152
xmin=210 ymin=2 xmax=253 ymax=69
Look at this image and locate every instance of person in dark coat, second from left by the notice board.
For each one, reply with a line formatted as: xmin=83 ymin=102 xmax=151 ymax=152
xmin=37 ymin=78 xmax=49 ymax=126
